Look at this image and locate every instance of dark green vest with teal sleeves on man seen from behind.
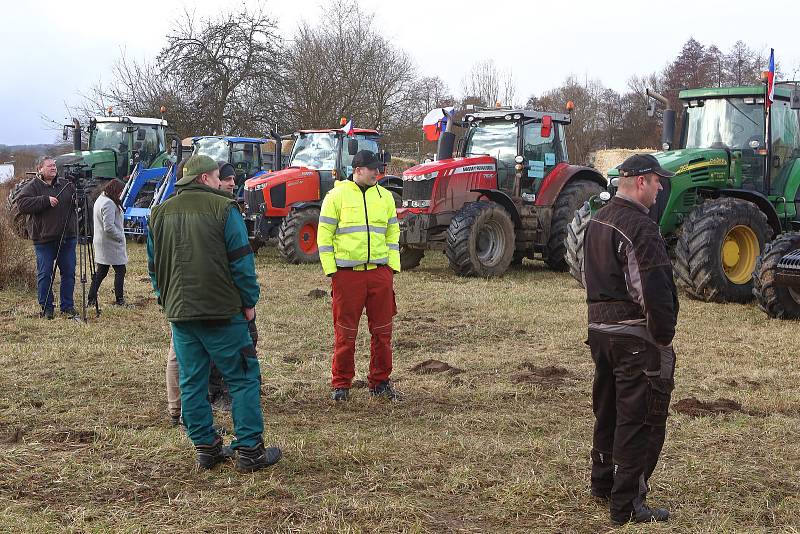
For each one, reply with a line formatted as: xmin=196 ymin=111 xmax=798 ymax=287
xmin=147 ymin=183 xmax=259 ymax=322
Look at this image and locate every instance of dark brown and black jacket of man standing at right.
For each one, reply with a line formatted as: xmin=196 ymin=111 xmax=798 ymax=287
xmin=584 ymin=196 xmax=678 ymax=345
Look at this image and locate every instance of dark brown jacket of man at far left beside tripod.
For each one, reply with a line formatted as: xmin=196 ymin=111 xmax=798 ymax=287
xmin=16 ymin=177 xmax=76 ymax=244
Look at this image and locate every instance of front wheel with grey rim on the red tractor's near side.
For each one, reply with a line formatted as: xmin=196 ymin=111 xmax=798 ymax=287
xmin=445 ymin=201 xmax=514 ymax=278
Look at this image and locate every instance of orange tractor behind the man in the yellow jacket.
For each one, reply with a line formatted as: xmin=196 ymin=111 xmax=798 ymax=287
xmin=244 ymin=128 xmax=402 ymax=263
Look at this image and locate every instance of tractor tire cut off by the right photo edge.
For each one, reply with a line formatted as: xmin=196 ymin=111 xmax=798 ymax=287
xmin=753 ymin=232 xmax=800 ymax=319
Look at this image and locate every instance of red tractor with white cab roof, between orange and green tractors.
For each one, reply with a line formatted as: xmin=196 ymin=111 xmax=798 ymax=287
xmin=398 ymin=107 xmax=607 ymax=277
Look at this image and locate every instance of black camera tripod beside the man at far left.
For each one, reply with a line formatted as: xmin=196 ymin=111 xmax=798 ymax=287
xmin=45 ymin=179 xmax=100 ymax=322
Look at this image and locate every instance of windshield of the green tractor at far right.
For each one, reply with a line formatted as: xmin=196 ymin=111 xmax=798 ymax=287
xmin=685 ymin=98 xmax=764 ymax=150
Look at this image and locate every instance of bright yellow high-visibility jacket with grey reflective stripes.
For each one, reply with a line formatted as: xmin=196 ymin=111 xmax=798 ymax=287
xmin=317 ymin=180 xmax=400 ymax=275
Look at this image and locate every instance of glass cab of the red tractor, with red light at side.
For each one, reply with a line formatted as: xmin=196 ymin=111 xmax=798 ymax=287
xmin=461 ymin=109 xmax=570 ymax=201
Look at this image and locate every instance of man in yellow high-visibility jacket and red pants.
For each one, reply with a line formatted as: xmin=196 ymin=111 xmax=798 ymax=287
xmin=317 ymin=150 xmax=400 ymax=401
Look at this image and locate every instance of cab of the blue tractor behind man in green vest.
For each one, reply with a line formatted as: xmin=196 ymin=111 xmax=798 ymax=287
xmin=192 ymin=136 xmax=268 ymax=198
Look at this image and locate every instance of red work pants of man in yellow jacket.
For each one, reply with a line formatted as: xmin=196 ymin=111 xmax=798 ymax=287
xmin=331 ymin=267 xmax=397 ymax=389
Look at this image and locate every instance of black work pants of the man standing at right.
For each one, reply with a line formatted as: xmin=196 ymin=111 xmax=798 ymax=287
xmin=588 ymin=330 xmax=675 ymax=521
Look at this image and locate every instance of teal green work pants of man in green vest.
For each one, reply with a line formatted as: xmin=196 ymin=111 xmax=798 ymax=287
xmin=172 ymin=313 xmax=264 ymax=449
